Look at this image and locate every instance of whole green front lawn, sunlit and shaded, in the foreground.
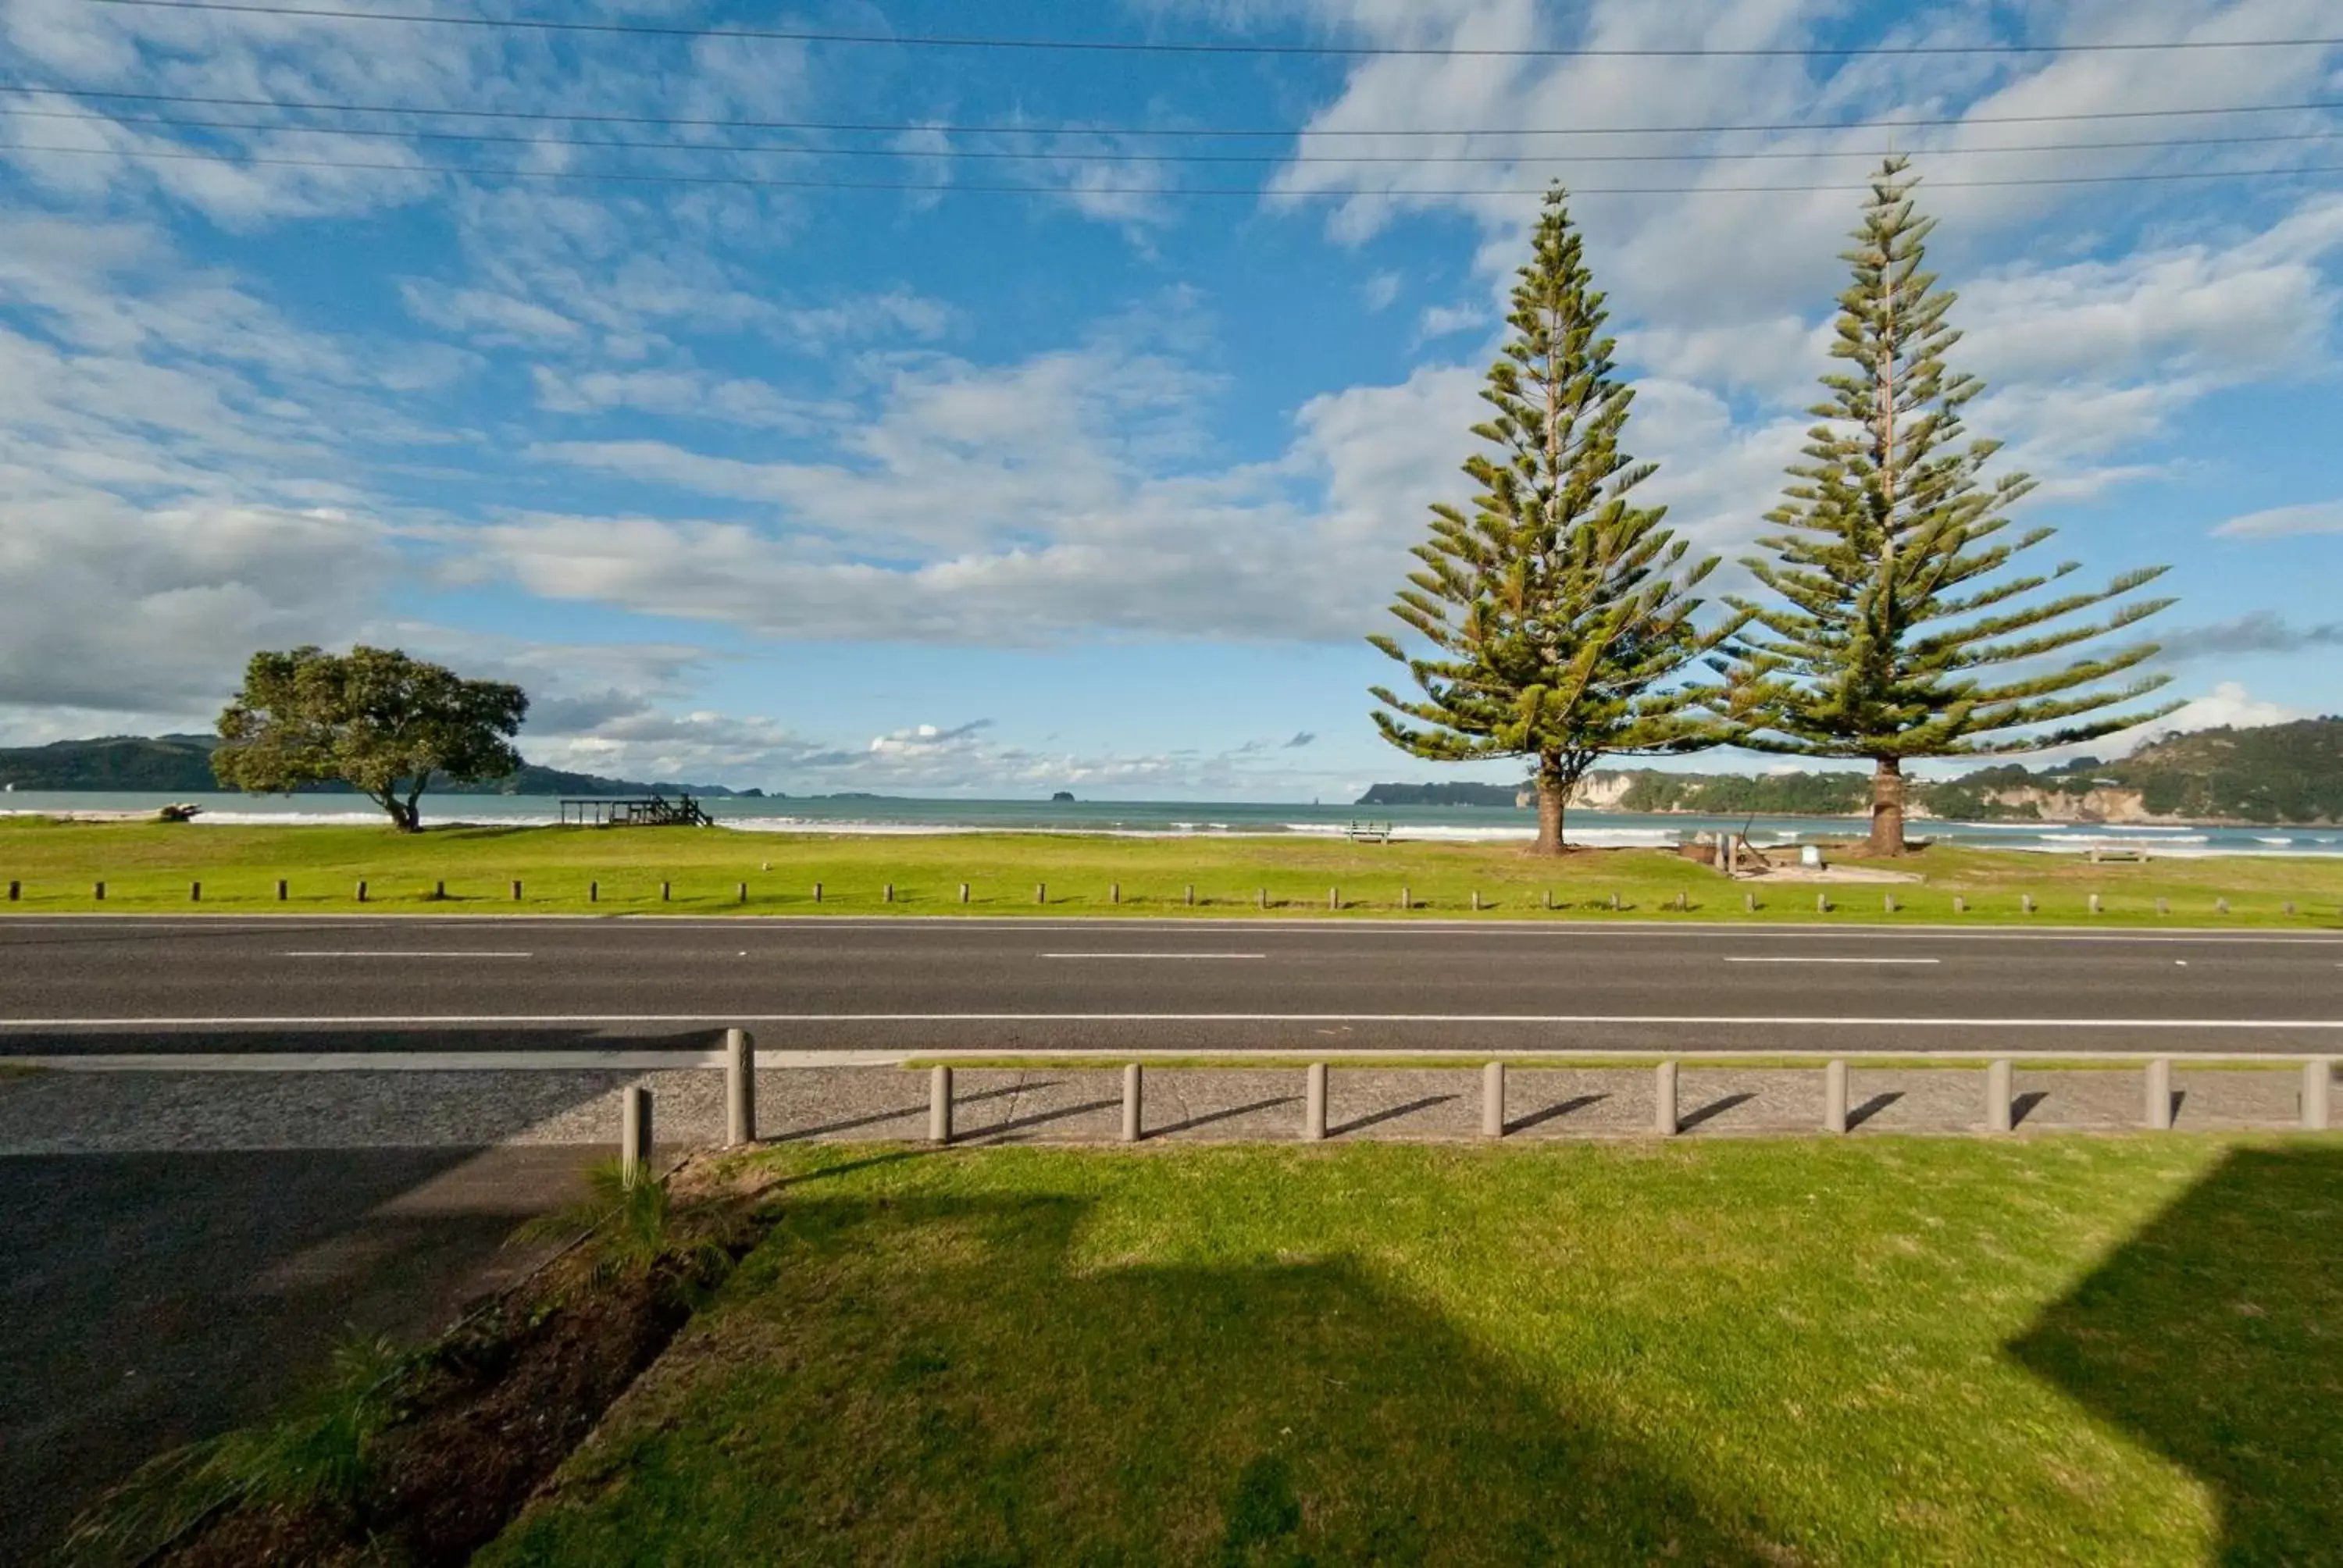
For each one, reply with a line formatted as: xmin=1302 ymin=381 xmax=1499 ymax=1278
xmin=480 ymin=1137 xmax=2343 ymax=1566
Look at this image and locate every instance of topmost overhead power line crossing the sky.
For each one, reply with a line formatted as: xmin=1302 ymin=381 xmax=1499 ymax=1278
xmin=73 ymin=0 xmax=2343 ymax=59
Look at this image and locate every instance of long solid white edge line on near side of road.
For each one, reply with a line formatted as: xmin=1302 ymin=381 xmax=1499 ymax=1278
xmin=0 ymin=1013 xmax=2343 ymax=1026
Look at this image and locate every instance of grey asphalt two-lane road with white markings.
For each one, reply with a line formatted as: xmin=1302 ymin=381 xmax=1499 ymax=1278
xmin=0 ymin=917 xmax=2343 ymax=1060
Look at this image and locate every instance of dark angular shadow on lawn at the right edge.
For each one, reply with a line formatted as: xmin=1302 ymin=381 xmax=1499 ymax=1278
xmin=2010 ymin=1144 xmax=2343 ymax=1563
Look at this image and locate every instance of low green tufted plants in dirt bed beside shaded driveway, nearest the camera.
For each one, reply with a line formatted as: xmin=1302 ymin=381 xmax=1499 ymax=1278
xmin=63 ymin=1329 xmax=415 ymax=1563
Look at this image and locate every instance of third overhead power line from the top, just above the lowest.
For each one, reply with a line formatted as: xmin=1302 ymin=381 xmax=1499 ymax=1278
xmin=0 ymin=103 xmax=2343 ymax=166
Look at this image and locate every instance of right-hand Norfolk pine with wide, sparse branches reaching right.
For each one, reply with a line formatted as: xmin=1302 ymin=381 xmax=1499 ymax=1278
xmin=1720 ymin=157 xmax=2172 ymax=856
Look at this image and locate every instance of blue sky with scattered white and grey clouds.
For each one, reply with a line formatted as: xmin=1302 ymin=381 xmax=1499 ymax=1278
xmin=0 ymin=0 xmax=2343 ymax=800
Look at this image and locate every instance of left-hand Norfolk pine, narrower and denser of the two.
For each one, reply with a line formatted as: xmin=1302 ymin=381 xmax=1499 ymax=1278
xmin=1368 ymin=187 xmax=1731 ymax=856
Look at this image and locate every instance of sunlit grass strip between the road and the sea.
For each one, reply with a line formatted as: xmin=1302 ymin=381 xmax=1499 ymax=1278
xmin=0 ymin=821 xmax=2343 ymax=928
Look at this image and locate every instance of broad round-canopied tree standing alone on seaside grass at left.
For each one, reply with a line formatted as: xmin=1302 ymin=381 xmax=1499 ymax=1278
xmin=211 ymin=647 xmax=530 ymax=832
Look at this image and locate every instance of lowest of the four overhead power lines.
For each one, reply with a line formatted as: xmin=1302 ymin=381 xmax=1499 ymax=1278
xmin=0 ymin=143 xmax=2343 ymax=201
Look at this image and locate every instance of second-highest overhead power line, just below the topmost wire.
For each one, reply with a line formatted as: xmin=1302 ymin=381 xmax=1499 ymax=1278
xmin=0 ymin=82 xmax=2343 ymax=138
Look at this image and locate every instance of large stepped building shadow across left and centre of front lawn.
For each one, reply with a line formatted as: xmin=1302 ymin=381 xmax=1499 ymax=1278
xmin=478 ymin=1196 xmax=1785 ymax=1566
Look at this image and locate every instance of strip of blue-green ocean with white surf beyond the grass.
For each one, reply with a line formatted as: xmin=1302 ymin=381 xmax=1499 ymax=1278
xmin=0 ymin=790 xmax=2343 ymax=856
